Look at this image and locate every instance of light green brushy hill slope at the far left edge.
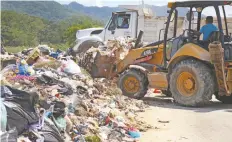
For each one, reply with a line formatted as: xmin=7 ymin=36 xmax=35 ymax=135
xmin=1 ymin=11 xmax=48 ymax=46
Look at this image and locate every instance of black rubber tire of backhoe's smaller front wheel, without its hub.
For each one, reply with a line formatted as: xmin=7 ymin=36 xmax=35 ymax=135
xmin=118 ymin=69 xmax=148 ymax=99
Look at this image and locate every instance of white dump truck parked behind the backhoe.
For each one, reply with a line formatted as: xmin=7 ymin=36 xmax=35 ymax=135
xmin=73 ymin=5 xmax=192 ymax=53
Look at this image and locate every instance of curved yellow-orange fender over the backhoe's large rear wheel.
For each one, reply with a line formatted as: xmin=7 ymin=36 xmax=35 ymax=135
xmin=168 ymin=43 xmax=211 ymax=68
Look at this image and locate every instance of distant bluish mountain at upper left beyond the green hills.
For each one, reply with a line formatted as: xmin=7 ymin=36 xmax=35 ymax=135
xmin=1 ymin=1 xmax=80 ymax=20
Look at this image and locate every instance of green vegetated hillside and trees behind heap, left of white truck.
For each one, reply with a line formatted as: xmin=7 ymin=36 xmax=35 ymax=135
xmin=1 ymin=11 xmax=101 ymax=46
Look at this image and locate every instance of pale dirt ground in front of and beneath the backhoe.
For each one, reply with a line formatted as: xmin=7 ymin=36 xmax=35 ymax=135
xmin=139 ymin=94 xmax=232 ymax=142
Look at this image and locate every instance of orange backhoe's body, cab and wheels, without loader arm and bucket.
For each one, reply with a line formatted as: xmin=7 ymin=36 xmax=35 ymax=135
xmin=119 ymin=1 xmax=232 ymax=106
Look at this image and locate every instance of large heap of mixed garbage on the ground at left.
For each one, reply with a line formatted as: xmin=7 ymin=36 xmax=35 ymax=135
xmin=0 ymin=43 xmax=151 ymax=142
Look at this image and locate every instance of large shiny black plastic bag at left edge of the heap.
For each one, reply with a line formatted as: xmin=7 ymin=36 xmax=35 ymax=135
xmin=3 ymin=86 xmax=39 ymax=134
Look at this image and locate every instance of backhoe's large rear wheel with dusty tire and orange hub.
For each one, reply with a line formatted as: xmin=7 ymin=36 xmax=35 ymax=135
xmin=170 ymin=59 xmax=216 ymax=107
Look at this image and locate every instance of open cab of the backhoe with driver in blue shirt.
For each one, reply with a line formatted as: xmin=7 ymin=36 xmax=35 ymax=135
xmin=164 ymin=2 xmax=232 ymax=61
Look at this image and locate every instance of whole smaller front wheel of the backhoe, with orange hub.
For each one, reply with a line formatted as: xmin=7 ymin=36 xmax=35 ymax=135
xmin=118 ymin=69 xmax=148 ymax=99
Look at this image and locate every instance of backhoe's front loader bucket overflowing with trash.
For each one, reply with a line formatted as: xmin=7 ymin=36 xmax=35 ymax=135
xmin=78 ymin=37 xmax=135 ymax=78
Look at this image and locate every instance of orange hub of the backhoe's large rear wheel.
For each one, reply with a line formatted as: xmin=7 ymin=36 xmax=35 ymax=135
xmin=176 ymin=72 xmax=196 ymax=96
